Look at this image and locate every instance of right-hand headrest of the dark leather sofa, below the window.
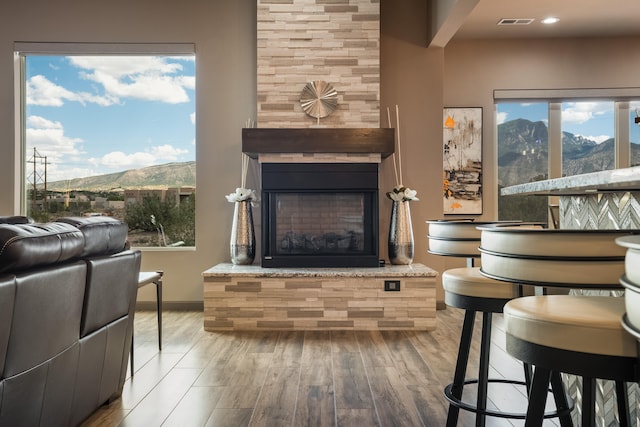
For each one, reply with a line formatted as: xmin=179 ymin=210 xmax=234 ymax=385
xmin=56 ymin=216 xmax=128 ymax=257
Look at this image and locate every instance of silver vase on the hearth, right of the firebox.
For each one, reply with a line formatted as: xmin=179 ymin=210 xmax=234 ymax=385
xmin=389 ymin=201 xmax=413 ymax=265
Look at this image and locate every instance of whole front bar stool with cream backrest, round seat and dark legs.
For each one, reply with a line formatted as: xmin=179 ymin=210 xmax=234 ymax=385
xmin=480 ymin=227 xmax=637 ymax=426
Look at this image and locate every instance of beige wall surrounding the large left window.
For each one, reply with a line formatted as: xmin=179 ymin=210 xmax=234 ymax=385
xmin=0 ymin=0 xmax=256 ymax=308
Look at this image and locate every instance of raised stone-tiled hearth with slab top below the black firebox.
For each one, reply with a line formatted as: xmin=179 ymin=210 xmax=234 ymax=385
xmin=203 ymin=264 xmax=438 ymax=331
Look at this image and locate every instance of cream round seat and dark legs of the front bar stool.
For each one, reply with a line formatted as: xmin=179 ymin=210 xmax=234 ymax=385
xmin=504 ymin=295 xmax=638 ymax=426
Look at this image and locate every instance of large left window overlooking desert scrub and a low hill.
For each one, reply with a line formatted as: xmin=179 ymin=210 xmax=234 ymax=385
xmin=19 ymin=45 xmax=196 ymax=247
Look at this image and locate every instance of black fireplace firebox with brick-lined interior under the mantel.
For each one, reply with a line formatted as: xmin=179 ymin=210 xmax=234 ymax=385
xmin=261 ymin=163 xmax=379 ymax=268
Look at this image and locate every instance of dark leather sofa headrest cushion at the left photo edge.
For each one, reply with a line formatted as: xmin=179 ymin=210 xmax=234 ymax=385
xmin=0 ymin=223 xmax=85 ymax=272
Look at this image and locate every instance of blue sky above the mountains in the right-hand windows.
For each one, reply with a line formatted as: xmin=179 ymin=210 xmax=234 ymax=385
xmin=498 ymin=102 xmax=640 ymax=143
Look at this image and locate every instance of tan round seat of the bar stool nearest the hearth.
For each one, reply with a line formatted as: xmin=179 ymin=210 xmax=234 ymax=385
xmin=442 ymin=267 xmax=518 ymax=299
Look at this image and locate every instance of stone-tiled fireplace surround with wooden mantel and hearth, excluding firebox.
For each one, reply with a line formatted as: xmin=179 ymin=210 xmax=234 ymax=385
xmin=203 ymin=0 xmax=437 ymax=331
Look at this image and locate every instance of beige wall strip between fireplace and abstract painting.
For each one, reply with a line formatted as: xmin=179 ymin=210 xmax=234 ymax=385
xmin=380 ymin=0 xmax=446 ymax=301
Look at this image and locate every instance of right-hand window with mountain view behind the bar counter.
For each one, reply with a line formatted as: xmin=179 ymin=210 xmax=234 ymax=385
xmin=496 ymin=89 xmax=640 ymax=222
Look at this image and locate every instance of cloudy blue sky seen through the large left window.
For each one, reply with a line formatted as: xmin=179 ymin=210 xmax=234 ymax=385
xmin=26 ymin=56 xmax=195 ymax=181
